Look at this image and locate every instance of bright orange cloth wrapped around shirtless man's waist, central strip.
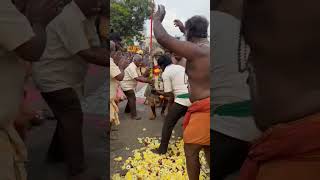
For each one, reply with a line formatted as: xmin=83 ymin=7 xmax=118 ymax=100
xmin=183 ymin=98 xmax=210 ymax=145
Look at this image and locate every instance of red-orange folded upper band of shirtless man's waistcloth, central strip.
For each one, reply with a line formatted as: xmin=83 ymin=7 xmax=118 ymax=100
xmin=183 ymin=98 xmax=210 ymax=129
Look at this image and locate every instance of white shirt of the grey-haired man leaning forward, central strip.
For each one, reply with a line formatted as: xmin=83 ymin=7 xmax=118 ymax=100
xmin=120 ymin=62 xmax=139 ymax=91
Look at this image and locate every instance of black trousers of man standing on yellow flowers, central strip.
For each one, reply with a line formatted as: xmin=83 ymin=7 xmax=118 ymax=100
xmin=159 ymin=103 xmax=188 ymax=153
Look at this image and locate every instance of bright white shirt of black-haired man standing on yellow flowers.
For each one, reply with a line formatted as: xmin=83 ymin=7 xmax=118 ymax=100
xmin=162 ymin=64 xmax=191 ymax=106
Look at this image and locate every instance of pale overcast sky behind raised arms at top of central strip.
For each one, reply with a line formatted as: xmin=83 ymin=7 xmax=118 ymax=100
xmin=145 ymin=0 xmax=210 ymax=37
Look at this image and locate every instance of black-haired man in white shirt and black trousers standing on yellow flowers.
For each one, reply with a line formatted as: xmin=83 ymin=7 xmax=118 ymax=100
xmin=152 ymin=55 xmax=191 ymax=154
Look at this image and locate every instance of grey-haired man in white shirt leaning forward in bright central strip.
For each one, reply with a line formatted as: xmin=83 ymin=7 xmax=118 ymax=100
xmin=120 ymin=55 xmax=153 ymax=120
